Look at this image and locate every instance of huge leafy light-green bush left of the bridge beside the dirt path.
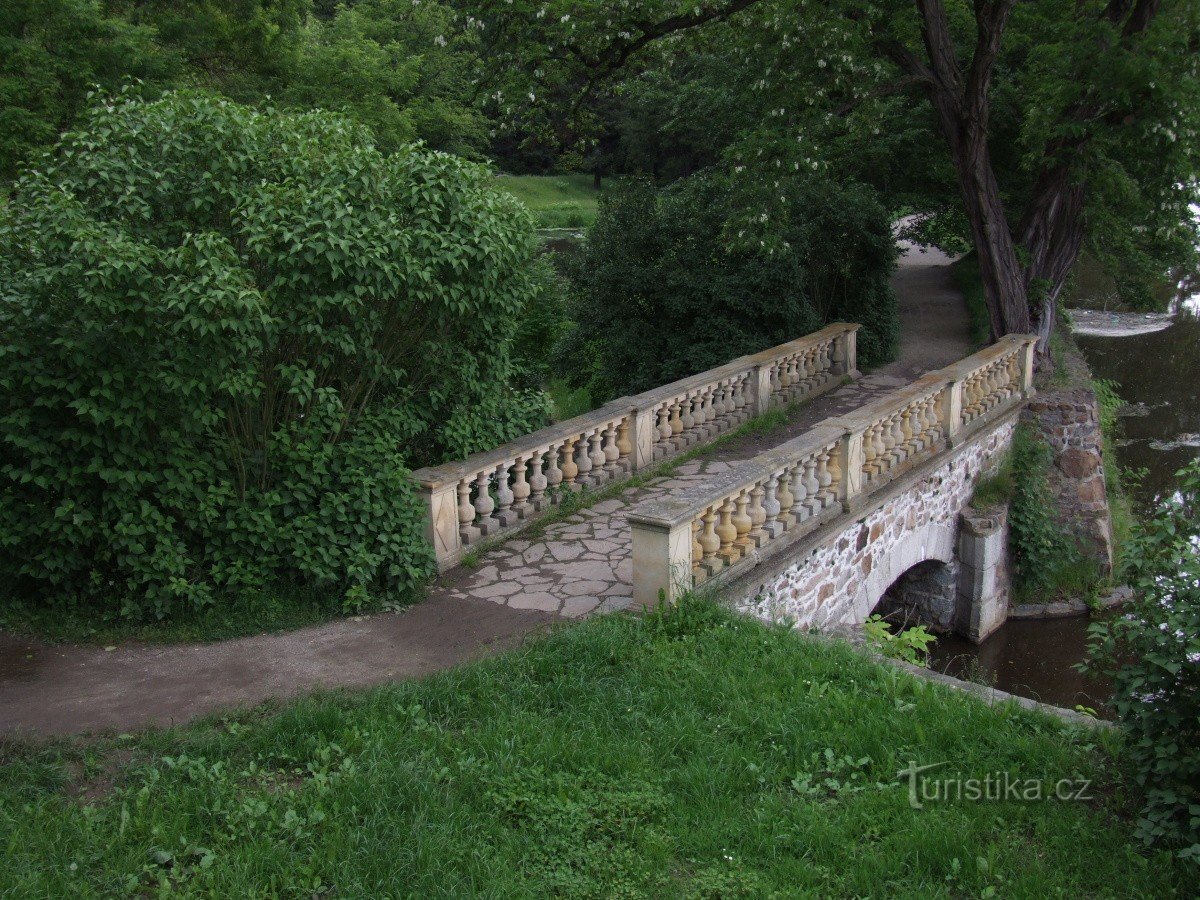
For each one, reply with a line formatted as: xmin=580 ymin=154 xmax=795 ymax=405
xmin=0 ymin=95 xmax=546 ymax=617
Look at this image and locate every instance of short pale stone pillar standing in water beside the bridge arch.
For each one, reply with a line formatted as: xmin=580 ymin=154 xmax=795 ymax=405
xmin=954 ymin=506 xmax=1010 ymax=643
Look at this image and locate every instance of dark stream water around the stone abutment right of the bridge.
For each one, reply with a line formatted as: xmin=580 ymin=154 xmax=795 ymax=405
xmin=930 ymin=298 xmax=1200 ymax=715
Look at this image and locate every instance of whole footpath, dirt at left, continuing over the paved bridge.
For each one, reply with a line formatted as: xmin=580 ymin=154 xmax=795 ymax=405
xmin=0 ymin=241 xmax=971 ymax=736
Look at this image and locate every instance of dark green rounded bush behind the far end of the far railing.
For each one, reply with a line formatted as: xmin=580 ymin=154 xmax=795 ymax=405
xmin=564 ymin=172 xmax=898 ymax=400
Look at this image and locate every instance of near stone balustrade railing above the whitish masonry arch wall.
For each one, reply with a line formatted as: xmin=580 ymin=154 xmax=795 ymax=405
xmin=629 ymin=335 xmax=1037 ymax=604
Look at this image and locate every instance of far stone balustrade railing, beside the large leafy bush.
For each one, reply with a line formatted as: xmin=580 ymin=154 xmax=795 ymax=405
xmin=413 ymin=323 xmax=859 ymax=571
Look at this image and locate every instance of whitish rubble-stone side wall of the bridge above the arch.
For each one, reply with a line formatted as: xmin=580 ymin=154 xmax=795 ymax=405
xmin=736 ymin=419 xmax=1015 ymax=628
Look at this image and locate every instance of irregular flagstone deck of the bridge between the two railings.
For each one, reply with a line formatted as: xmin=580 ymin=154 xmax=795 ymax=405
xmin=430 ymin=374 xmax=907 ymax=618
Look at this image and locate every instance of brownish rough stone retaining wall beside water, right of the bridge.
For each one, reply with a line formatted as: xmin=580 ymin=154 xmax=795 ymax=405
xmin=1021 ymin=388 xmax=1112 ymax=568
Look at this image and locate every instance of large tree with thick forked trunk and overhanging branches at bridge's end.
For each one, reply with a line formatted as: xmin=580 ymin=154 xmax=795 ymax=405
xmin=458 ymin=0 xmax=1200 ymax=347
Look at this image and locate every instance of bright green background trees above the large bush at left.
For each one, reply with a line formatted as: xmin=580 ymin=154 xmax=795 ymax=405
xmin=0 ymin=0 xmax=488 ymax=179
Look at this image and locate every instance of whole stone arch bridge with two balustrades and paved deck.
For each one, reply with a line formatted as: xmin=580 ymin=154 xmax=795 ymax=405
xmin=414 ymin=324 xmax=1036 ymax=641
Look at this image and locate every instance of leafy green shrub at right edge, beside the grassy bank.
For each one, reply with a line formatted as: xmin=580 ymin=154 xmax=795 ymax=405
xmin=1087 ymin=462 xmax=1200 ymax=864
